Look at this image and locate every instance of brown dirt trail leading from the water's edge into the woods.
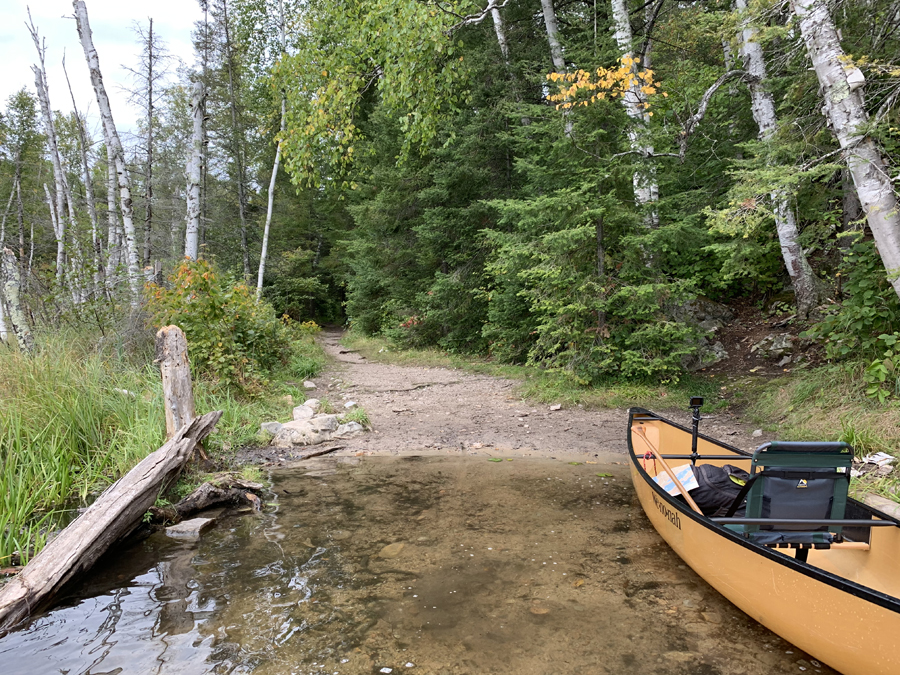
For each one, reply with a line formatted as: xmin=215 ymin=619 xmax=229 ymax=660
xmin=244 ymin=331 xmax=767 ymax=465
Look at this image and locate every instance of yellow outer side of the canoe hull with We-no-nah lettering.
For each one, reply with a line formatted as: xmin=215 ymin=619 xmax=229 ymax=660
xmin=631 ymin=412 xmax=900 ymax=675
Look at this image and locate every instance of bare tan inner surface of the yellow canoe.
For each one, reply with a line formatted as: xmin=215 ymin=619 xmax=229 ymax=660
xmin=630 ymin=410 xmax=900 ymax=598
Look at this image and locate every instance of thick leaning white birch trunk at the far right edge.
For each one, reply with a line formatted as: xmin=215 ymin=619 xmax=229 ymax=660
xmin=791 ymin=0 xmax=900 ymax=296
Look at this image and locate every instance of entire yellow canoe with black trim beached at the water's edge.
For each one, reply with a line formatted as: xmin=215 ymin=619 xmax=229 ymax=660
xmin=628 ymin=408 xmax=900 ymax=675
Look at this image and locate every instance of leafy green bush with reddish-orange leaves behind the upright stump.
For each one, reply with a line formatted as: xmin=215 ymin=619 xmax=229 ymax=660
xmin=147 ymin=260 xmax=291 ymax=387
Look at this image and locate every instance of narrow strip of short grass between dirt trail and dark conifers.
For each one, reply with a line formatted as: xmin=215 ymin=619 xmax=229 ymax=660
xmin=342 ymin=332 xmax=727 ymax=411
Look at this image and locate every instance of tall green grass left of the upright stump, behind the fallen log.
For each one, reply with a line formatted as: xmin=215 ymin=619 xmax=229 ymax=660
xmin=0 ymin=338 xmax=165 ymax=565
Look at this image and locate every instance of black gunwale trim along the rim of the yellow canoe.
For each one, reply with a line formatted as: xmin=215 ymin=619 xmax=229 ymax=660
xmin=628 ymin=407 xmax=900 ymax=614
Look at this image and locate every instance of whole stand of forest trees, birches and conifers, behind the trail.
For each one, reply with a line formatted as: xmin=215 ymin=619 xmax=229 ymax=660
xmin=0 ymin=0 xmax=900 ymax=396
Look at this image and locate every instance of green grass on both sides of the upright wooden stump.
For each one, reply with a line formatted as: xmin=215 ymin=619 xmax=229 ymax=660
xmin=0 ymin=335 xmax=325 ymax=567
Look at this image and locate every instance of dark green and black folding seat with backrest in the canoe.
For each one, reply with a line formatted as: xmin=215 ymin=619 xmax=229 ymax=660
xmin=726 ymin=441 xmax=853 ymax=559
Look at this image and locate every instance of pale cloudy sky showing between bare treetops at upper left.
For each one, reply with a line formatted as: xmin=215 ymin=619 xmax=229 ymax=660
xmin=0 ymin=0 xmax=203 ymax=132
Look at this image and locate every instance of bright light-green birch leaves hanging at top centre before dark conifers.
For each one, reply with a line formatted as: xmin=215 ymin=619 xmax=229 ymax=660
xmin=276 ymin=0 xmax=476 ymax=187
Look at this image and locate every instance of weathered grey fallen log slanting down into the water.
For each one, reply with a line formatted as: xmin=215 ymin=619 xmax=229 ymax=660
xmin=0 ymin=411 xmax=222 ymax=636
